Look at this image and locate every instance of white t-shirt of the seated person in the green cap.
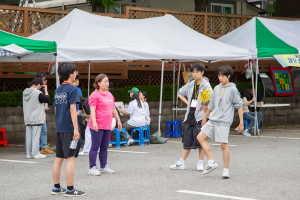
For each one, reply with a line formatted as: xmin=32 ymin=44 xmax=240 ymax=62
xmin=126 ymin=100 xmax=146 ymax=127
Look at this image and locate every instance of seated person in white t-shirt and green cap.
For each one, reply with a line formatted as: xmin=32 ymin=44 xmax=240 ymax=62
xmin=119 ymin=87 xmax=146 ymax=145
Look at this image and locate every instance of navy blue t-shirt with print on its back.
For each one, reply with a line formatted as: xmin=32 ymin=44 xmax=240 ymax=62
xmin=53 ymin=84 xmax=80 ymax=133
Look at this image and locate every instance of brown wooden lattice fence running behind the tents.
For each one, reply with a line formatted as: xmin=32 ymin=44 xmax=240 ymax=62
xmin=0 ymin=5 xmax=297 ymax=91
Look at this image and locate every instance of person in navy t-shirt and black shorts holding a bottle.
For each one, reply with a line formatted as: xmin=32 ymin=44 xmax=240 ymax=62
xmin=52 ymin=63 xmax=86 ymax=196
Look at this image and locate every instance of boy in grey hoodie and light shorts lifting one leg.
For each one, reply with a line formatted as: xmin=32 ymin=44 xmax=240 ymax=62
xmin=197 ymin=65 xmax=244 ymax=179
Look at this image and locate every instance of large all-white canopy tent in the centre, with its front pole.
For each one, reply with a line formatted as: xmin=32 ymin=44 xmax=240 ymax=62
xmin=3 ymin=9 xmax=251 ymax=134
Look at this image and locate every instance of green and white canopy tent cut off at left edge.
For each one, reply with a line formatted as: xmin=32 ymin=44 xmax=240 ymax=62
xmin=0 ymin=30 xmax=59 ymax=84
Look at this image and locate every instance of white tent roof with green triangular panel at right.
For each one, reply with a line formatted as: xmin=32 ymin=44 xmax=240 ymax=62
xmin=218 ymin=17 xmax=300 ymax=58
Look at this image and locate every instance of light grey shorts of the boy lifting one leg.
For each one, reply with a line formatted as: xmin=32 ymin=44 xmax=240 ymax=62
xmin=201 ymin=121 xmax=229 ymax=143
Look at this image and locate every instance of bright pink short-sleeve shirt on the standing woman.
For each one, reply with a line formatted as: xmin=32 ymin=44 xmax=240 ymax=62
xmin=88 ymin=90 xmax=115 ymax=130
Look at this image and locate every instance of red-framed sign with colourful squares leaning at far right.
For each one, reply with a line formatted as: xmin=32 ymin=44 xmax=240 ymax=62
xmin=270 ymin=67 xmax=295 ymax=96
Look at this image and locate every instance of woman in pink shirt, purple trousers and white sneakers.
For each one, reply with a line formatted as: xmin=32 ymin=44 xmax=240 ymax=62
xmin=88 ymin=74 xmax=122 ymax=176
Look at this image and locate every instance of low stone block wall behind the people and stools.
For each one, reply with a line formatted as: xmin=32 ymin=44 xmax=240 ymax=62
xmin=0 ymin=97 xmax=300 ymax=143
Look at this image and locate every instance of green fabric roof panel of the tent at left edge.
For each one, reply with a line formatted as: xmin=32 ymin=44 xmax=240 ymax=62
xmin=0 ymin=30 xmax=56 ymax=53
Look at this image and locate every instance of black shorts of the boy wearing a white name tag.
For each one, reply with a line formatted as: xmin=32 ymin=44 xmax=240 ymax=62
xmin=182 ymin=123 xmax=202 ymax=149
